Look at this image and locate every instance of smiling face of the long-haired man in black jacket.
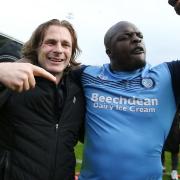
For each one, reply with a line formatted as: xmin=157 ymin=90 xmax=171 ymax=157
xmin=38 ymin=25 xmax=72 ymax=78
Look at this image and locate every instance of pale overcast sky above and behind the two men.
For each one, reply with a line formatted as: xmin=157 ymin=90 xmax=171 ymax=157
xmin=0 ymin=0 xmax=180 ymax=65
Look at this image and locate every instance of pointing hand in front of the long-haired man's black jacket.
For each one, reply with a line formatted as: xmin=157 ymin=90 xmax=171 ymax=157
xmin=0 ymin=63 xmax=56 ymax=92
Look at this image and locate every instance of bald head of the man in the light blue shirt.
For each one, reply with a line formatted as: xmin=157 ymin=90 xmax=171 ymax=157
xmin=105 ymin=21 xmax=146 ymax=71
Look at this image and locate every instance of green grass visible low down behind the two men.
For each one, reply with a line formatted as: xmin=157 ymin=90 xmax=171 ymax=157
xmin=75 ymin=143 xmax=180 ymax=180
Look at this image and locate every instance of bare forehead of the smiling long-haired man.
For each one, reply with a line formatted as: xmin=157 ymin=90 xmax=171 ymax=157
xmin=44 ymin=25 xmax=72 ymax=42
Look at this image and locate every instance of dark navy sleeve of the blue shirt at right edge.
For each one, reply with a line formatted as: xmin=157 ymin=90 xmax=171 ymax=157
xmin=167 ymin=60 xmax=180 ymax=105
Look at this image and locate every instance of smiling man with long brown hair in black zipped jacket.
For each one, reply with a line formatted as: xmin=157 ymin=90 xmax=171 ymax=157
xmin=0 ymin=19 xmax=85 ymax=180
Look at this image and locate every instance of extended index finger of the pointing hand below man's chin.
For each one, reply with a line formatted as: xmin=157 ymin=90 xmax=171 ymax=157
xmin=32 ymin=65 xmax=56 ymax=83
